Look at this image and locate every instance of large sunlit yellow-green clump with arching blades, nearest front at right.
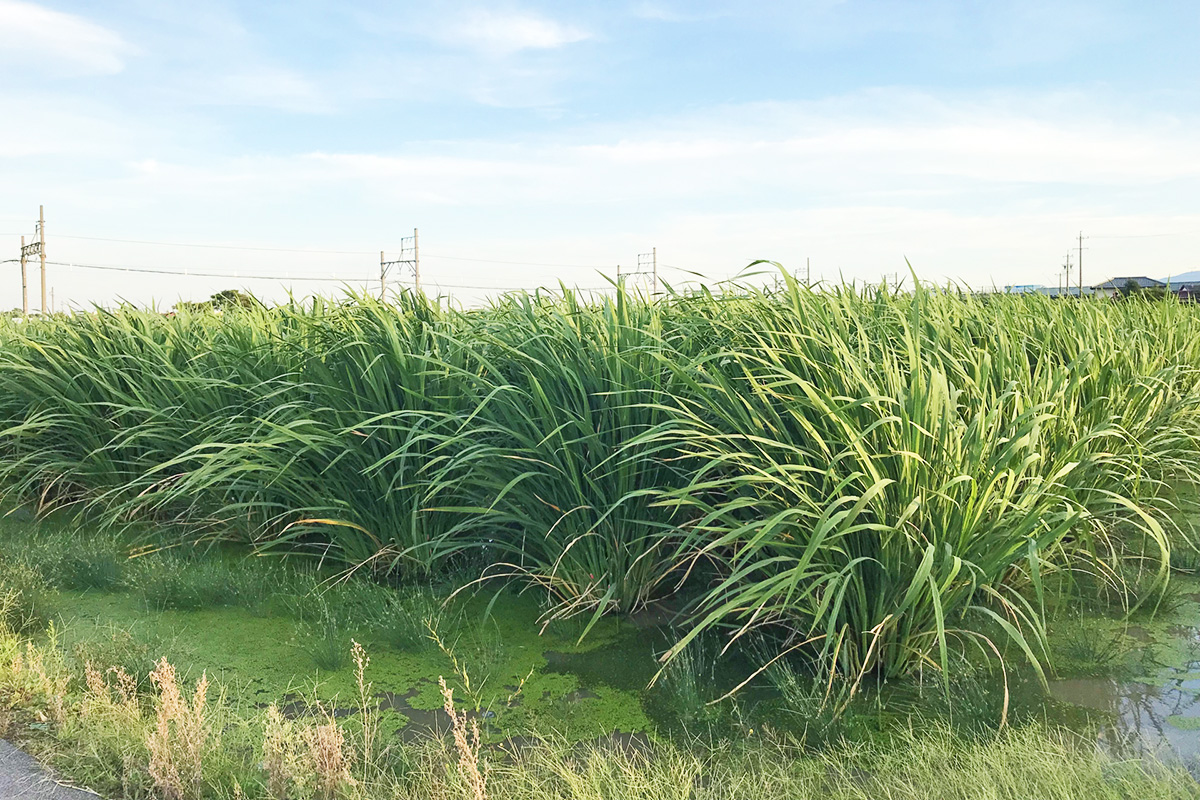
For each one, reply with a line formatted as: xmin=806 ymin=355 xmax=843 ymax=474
xmin=653 ymin=277 xmax=1198 ymax=682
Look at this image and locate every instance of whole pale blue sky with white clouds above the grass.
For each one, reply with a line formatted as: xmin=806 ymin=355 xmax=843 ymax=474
xmin=0 ymin=0 xmax=1200 ymax=307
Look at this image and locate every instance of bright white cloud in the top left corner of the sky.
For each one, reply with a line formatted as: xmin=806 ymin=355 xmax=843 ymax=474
xmin=0 ymin=0 xmax=131 ymax=74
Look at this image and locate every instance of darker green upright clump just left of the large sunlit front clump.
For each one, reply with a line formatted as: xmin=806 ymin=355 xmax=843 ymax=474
xmin=448 ymin=290 xmax=685 ymax=618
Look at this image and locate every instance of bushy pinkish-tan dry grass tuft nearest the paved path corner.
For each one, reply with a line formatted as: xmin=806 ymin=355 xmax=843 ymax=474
xmin=146 ymin=658 xmax=214 ymax=800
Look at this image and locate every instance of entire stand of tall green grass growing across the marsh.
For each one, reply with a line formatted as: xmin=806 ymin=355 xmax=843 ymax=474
xmin=0 ymin=275 xmax=1200 ymax=685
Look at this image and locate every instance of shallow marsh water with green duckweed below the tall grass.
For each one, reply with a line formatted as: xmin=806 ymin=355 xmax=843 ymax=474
xmin=0 ymin=506 xmax=1200 ymax=777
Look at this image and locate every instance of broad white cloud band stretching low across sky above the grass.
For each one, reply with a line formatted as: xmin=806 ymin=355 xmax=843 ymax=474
xmin=0 ymin=90 xmax=1200 ymax=307
